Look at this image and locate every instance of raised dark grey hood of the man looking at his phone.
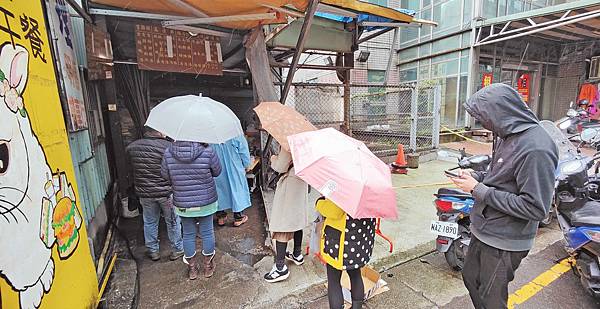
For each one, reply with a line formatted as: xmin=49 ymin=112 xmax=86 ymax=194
xmin=465 ymin=84 xmax=539 ymax=138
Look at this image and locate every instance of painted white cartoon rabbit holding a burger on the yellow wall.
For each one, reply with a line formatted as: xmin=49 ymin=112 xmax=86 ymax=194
xmin=0 ymin=43 xmax=82 ymax=308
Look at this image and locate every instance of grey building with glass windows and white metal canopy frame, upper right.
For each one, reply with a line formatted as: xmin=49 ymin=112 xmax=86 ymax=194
xmin=299 ymin=0 xmax=600 ymax=130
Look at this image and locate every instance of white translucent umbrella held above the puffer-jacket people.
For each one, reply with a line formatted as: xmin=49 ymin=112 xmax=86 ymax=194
xmin=146 ymin=95 xmax=244 ymax=144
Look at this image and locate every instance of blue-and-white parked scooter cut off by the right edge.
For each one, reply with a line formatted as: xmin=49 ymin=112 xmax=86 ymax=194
xmin=554 ymin=125 xmax=600 ymax=299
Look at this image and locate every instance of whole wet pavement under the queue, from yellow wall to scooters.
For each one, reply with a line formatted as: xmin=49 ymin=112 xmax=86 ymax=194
xmin=104 ymin=156 xmax=600 ymax=309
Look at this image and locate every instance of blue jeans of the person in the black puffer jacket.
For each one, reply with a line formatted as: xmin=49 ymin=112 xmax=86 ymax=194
xmin=140 ymin=197 xmax=183 ymax=252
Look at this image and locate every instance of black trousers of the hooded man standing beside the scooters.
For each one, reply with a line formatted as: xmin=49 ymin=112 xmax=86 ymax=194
xmin=462 ymin=236 xmax=529 ymax=309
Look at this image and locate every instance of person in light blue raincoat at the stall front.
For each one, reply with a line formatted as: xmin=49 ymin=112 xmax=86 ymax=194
xmin=211 ymin=135 xmax=252 ymax=227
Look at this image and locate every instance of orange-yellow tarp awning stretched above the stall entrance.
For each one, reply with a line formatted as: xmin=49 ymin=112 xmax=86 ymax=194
xmin=91 ymin=0 xmax=414 ymax=29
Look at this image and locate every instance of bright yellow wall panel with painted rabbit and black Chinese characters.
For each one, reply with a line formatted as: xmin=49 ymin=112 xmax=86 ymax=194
xmin=0 ymin=0 xmax=98 ymax=308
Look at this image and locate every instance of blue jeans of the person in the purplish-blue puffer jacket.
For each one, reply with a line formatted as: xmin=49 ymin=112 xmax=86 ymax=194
xmin=181 ymin=215 xmax=215 ymax=258
